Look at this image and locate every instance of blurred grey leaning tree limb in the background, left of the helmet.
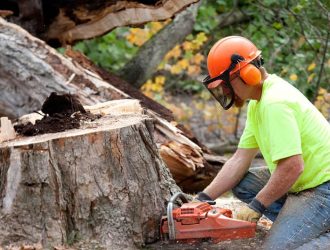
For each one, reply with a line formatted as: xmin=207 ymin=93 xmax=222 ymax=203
xmin=120 ymin=2 xmax=201 ymax=88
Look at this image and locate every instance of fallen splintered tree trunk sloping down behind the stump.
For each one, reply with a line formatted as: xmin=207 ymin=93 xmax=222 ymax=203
xmin=0 ymin=19 xmax=225 ymax=192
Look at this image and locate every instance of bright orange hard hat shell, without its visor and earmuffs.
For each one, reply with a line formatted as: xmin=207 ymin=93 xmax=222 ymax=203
xmin=207 ymin=36 xmax=261 ymax=88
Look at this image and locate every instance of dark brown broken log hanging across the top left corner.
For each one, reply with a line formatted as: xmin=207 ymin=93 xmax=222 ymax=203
xmin=0 ymin=0 xmax=198 ymax=45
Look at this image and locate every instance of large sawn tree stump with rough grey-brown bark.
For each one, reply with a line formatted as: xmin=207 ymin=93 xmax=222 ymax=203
xmin=0 ymin=105 xmax=179 ymax=249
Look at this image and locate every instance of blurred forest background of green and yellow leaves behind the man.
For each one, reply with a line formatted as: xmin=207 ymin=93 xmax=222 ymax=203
xmin=60 ymin=0 xmax=330 ymax=149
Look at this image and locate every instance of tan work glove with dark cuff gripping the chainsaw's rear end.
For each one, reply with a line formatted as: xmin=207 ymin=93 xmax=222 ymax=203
xmin=235 ymin=198 xmax=266 ymax=223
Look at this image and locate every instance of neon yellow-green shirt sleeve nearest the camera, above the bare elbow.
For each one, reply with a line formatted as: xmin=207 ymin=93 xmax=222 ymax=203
xmin=263 ymin=103 xmax=302 ymax=164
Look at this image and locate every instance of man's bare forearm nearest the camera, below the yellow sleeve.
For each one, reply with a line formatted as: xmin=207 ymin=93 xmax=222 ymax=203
xmin=256 ymin=155 xmax=304 ymax=207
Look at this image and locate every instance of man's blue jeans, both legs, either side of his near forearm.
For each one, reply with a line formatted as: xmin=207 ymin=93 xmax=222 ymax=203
xmin=233 ymin=168 xmax=330 ymax=250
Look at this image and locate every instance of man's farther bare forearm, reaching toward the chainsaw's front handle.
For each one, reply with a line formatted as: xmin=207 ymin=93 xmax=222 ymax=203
xmin=203 ymin=148 xmax=258 ymax=199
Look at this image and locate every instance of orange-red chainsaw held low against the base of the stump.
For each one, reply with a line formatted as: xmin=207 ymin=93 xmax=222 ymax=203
xmin=160 ymin=192 xmax=256 ymax=243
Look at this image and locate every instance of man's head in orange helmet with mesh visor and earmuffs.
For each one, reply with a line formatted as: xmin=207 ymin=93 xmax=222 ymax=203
xmin=203 ymin=36 xmax=263 ymax=109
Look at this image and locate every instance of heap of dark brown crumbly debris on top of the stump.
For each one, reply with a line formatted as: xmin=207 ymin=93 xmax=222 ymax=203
xmin=14 ymin=92 xmax=100 ymax=136
